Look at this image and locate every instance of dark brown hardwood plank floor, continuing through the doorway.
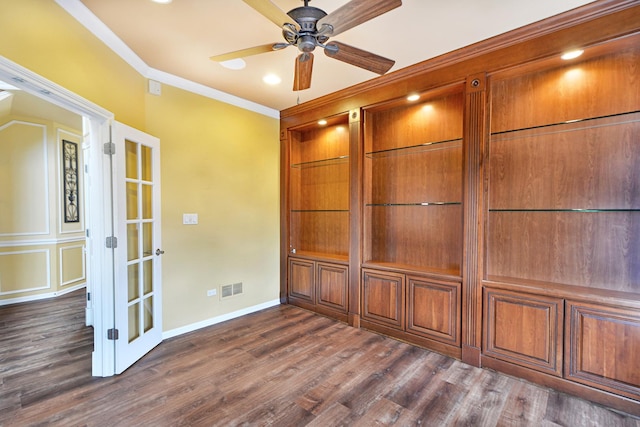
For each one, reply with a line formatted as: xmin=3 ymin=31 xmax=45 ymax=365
xmin=0 ymin=291 xmax=640 ymax=427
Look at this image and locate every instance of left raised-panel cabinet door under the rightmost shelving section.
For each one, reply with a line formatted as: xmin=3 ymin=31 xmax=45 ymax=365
xmin=483 ymin=288 xmax=564 ymax=376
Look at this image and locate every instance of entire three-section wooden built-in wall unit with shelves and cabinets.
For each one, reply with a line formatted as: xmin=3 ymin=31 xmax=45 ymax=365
xmin=281 ymin=0 xmax=640 ymax=415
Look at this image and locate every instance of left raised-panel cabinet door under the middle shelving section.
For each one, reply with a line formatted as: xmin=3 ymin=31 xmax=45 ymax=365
xmin=362 ymin=269 xmax=405 ymax=330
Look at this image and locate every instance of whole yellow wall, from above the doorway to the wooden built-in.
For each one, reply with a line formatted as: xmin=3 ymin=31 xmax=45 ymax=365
xmin=0 ymin=0 xmax=279 ymax=330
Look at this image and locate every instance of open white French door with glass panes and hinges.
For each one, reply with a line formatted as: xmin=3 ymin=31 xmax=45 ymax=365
xmin=112 ymin=123 xmax=163 ymax=374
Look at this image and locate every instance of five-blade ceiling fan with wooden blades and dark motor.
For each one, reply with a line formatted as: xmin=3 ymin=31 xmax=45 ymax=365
xmin=211 ymin=0 xmax=402 ymax=91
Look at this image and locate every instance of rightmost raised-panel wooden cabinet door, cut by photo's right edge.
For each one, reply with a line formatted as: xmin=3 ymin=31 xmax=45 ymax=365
xmin=565 ymin=301 xmax=640 ymax=399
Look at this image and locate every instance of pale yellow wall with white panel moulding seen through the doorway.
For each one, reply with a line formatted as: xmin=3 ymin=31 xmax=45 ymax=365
xmin=0 ymin=115 xmax=86 ymax=304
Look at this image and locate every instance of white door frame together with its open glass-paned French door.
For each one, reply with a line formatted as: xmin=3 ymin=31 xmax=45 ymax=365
xmin=0 ymin=56 xmax=163 ymax=376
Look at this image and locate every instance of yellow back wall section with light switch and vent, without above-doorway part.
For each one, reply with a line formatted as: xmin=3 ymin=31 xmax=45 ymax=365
xmin=147 ymin=86 xmax=279 ymax=330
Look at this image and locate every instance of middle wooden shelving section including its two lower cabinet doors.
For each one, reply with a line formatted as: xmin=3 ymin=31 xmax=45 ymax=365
xmin=362 ymin=85 xmax=464 ymax=357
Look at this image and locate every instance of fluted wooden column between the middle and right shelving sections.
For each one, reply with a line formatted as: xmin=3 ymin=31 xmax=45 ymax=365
xmin=462 ymin=73 xmax=487 ymax=366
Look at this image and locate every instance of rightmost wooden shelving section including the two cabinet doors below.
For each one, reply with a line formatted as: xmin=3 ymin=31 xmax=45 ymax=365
xmin=482 ymin=33 xmax=640 ymax=408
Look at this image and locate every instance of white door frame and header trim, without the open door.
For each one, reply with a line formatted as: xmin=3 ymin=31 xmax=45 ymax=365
xmin=0 ymin=55 xmax=115 ymax=377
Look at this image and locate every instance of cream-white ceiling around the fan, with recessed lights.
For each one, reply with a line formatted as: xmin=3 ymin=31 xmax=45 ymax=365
xmin=67 ymin=0 xmax=590 ymax=111
